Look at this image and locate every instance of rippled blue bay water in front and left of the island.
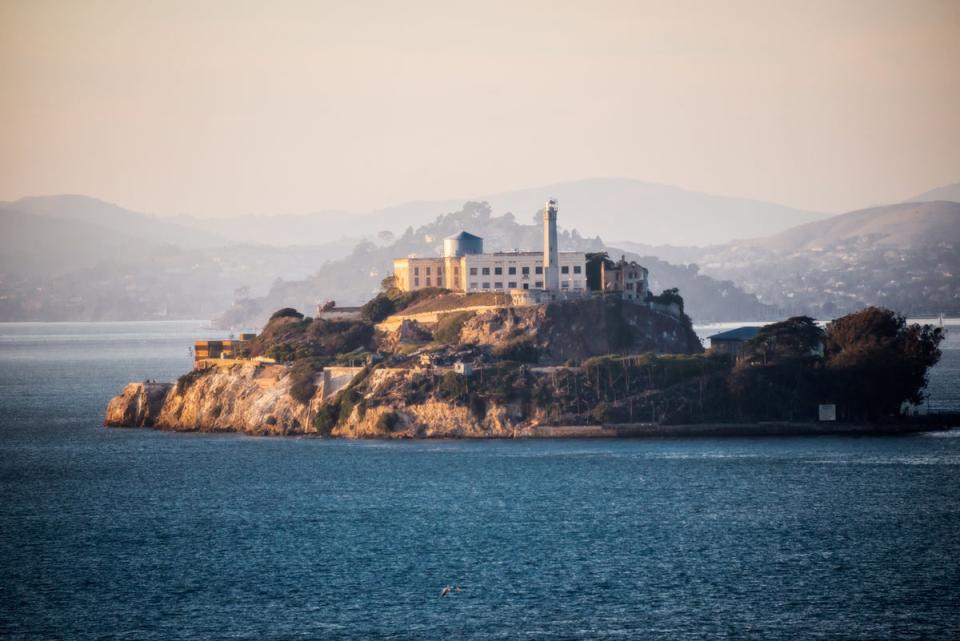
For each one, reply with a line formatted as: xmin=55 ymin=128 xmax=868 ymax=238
xmin=0 ymin=323 xmax=960 ymax=640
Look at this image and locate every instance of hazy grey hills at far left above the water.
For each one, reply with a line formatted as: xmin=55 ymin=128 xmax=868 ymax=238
xmin=0 ymin=196 xmax=352 ymax=321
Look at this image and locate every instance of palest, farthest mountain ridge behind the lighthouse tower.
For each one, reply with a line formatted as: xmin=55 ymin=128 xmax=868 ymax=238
xmin=156 ymin=178 xmax=826 ymax=245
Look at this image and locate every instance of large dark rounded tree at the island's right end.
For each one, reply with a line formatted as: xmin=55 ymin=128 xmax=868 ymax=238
xmin=826 ymin=307 xmax=943 ymax=420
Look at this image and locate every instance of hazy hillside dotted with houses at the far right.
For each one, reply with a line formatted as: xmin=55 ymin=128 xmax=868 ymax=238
xmin=690 ymin=201 xmax=960 ymax=318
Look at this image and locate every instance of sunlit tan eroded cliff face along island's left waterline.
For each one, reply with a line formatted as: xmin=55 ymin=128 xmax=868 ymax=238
xmin=104 ymin=364 xmax=530 ymax=438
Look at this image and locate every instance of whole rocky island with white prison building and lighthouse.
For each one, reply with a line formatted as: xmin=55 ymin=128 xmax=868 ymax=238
xmin=105 ymin=200 xmax=953 ymax=438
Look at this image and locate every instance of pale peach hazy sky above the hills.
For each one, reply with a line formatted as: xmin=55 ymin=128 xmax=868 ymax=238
xmin=0 ymin=0 xmax=960 ymax=215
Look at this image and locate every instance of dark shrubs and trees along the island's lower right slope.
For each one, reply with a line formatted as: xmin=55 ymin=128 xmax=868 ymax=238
xmin=324 ymin=308 xmax=942 ymax=429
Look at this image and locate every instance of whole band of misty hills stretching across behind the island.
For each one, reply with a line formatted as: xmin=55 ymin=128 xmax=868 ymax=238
xmin=0 ymin=179 xmax=960 ymax=324
